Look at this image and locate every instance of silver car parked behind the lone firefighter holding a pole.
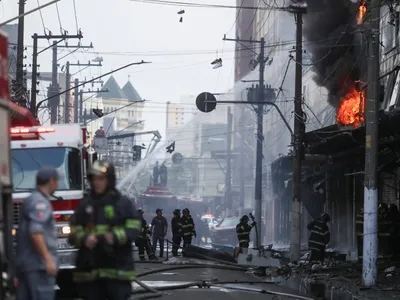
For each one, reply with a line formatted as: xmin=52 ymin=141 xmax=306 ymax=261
xmin=210 ymin=217 xmax=240 ymax=246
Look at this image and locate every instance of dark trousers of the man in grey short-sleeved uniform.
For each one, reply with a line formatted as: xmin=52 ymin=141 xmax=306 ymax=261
xmin=16 ymin=270 xmax=56 ymax=300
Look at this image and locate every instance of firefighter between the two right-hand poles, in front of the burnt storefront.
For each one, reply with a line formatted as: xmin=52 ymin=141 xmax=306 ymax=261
xmin=307 ymin=213 xmax=331 ymax=263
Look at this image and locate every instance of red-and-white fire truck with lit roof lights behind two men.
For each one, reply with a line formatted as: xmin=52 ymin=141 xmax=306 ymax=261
xmin=10 ymin=121 xmax=87 ymax=296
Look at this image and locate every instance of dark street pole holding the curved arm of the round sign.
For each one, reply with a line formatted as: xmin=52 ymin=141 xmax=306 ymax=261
xmin=290 ymin=11 xmax=304 ymax=261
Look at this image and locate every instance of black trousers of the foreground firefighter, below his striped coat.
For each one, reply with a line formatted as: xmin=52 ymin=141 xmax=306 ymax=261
xmin=79 ymin=279 xmax=132 ymax=300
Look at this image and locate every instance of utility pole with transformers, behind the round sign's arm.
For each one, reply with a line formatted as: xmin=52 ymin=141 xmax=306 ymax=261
xmin=254 ymin=38 xmax=265 ymax=248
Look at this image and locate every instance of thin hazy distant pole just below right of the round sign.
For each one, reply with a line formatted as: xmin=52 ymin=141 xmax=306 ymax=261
xmin=225 ymin=106 xmax=233 ymax=216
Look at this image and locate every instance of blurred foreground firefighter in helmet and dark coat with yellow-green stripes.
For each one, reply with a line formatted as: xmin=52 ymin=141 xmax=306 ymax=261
xmin=69 ymin=160 xmax=142 ymax=300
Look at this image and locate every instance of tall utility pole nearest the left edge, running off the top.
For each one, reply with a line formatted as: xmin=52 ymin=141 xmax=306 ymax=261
xmin=14 ymin=0 xmax=27 ymax=107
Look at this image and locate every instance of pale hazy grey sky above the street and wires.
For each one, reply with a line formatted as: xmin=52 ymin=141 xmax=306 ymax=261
xmin=0 ymin=0 xmax=236 ymax=140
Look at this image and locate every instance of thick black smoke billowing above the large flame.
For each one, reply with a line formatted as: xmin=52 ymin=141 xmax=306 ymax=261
xmin=303 ymin=0 xmax=362 ymax=105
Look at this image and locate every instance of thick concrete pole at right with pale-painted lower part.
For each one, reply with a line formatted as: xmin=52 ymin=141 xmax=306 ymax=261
xmin=362 ymin=0 xmax=380 ymax=287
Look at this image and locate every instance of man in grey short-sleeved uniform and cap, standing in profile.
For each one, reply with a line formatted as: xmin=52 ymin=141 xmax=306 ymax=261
xmin=16 ymin=168 xmax=58 ymax=300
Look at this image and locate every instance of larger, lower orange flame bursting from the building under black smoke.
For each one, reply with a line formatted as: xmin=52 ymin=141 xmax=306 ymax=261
xmin=336 ymin=87 xmax=365 ymax=127
